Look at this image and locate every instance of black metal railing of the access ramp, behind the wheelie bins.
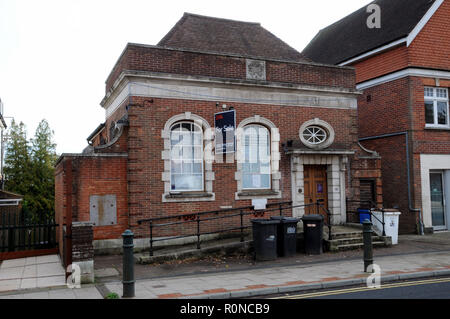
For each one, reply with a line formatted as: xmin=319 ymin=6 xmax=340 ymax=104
xmin=138 ymin=201 xmax=331 ymax=256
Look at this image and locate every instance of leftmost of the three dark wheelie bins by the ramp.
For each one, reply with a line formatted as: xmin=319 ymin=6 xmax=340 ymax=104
xmin=252 ymin=219 xmax=280 ymax=261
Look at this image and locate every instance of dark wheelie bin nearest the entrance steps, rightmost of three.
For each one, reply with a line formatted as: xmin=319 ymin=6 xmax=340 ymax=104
xmin=302 ymin=215 xmax=324 ymax=255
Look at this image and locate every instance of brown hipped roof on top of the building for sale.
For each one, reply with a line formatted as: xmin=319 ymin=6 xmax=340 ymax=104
xmin=158 ymin=13 xmax=308 ymax=62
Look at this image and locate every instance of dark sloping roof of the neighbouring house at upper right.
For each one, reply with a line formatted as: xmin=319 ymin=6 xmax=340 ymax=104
xmin=302 ymin=0 xmax=435 ymax=64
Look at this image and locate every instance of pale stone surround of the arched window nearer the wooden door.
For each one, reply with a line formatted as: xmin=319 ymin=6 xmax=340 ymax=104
xmin=235 ymin=115 xmax=281 ymax=200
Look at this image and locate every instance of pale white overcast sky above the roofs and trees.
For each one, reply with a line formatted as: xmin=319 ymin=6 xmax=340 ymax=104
xmin=0 ymin=0 xmax=370 ymax=154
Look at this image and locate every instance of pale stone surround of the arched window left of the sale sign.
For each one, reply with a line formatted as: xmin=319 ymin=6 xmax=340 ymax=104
xmin=161 ymin=112 xmax=215 ymax=203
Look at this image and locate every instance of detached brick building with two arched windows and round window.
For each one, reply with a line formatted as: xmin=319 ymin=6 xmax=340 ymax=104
xmin=56 ymin=14 xmax=382 ymax=254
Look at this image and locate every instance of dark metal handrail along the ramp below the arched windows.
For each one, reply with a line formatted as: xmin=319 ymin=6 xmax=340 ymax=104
xmin=137 ymin=201 xmax=324 ymax=256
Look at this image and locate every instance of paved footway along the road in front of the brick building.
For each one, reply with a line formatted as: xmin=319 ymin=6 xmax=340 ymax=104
xmin=0 ymin=232 xmax=450 ymax=299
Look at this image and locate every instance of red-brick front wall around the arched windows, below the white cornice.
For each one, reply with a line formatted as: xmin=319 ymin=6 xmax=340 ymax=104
xmin=124 ymin=97 xmax=380 ymax=237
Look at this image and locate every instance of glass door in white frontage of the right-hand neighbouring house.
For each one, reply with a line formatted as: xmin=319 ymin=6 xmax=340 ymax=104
xmin=430 ymin=172 xmax=446 ymax=230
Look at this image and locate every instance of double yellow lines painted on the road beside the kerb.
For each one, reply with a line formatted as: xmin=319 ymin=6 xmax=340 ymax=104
xmin=270 ymin=278 xmax=450 ymax=299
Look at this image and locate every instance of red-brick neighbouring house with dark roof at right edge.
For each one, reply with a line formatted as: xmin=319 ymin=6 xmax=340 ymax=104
xmin=302 ymin=0 xmax=450 ymax=233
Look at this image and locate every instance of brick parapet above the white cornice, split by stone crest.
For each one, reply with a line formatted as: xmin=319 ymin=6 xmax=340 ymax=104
xmin=106 ymin=44 xmax=355 ymax=92
